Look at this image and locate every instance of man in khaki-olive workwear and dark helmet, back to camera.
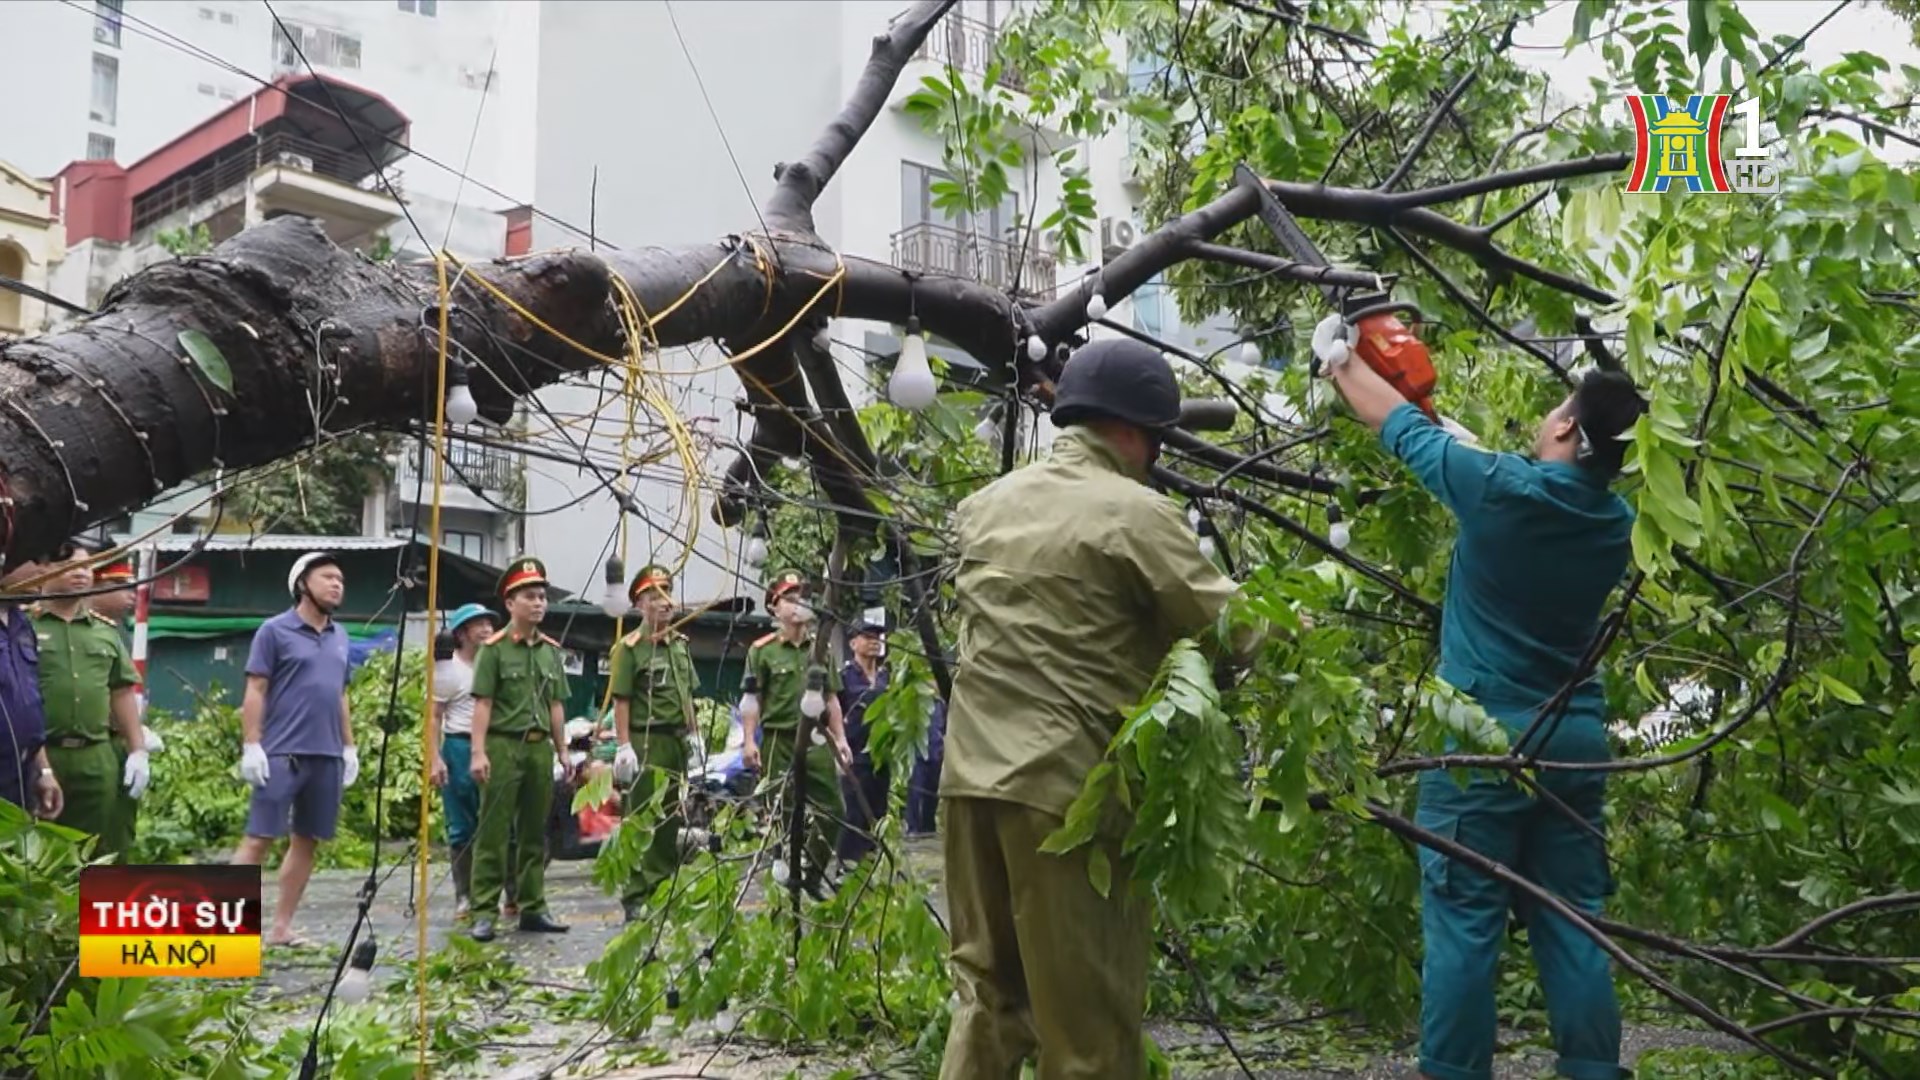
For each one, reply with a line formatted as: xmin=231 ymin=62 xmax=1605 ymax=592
xmin=939 ymin=340 xmax=1260 ymax=1080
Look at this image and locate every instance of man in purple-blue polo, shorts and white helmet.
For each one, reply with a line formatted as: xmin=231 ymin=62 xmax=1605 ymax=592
xmin=234 ymin=552 xmax=359 ymax=945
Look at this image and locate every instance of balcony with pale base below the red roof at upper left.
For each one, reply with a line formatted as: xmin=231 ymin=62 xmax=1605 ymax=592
xmin=132 ymin=133 xmax=403 ymax=246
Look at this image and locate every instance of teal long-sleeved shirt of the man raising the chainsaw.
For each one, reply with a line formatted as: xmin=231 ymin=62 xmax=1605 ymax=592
xmin=1380 ymin=404 xmax=1634 ymax=728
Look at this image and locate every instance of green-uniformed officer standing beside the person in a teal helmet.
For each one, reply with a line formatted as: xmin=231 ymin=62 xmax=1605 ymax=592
xmin=468 ymin=555 xmax=566 ymax=942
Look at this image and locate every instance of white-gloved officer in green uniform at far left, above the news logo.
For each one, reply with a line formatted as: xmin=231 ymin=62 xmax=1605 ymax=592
xmin=33 ymin=544 xmax=152 ymax=861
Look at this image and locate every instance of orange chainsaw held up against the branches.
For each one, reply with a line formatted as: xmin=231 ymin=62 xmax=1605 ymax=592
xmin=1233 ymin=161 xmax=1440 ymax=421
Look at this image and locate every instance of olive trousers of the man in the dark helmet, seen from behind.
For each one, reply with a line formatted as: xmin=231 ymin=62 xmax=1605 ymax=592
xmin=941 ymin=798 xmax=1152 ymax=1080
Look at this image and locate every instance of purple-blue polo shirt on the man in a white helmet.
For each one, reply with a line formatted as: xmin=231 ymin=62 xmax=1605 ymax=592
xmin=246 ymin=609 xmax=351 ymax=757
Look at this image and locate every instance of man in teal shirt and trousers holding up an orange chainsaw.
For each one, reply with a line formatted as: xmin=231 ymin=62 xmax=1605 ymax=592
xmin=1323 ymin=317 xmax=1645 ymax=1080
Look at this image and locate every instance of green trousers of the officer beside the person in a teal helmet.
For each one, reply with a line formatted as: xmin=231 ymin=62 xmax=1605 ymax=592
xmin=470 ymin=732 xmax=553 ymax=919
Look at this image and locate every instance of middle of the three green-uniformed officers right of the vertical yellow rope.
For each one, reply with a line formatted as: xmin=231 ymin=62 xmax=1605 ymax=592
xmin=609 ymin=563 xmax=701 ymax=922
